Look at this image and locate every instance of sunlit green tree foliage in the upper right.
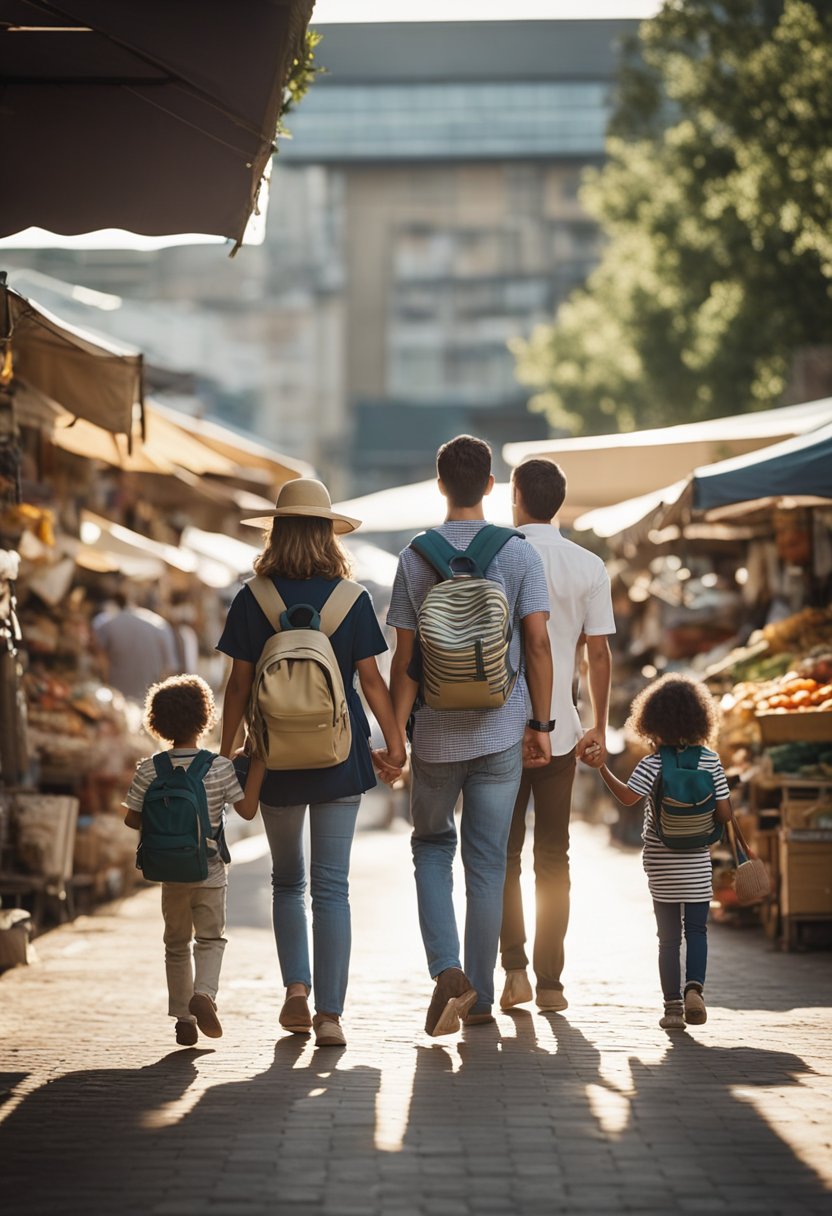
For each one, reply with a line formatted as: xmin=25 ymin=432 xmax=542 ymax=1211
xmin=515 ymin=0 xmax=832 ymax=433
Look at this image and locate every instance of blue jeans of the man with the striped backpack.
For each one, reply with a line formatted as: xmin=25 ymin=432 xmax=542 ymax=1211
xmin=410 ymin=743 xmax=523 ymax=1013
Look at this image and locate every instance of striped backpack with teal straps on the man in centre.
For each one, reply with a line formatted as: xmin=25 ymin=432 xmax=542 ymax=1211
xmin=410 ymin=524 xmax=523 ymax=709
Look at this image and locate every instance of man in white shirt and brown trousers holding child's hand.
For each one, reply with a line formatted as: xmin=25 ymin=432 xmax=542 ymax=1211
xmin=500 ymin=460 xmax=615 ymax=1013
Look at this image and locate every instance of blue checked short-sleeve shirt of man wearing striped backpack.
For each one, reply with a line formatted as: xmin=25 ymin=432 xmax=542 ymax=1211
xmin=387 ymin=519 xmax=549 ymax=764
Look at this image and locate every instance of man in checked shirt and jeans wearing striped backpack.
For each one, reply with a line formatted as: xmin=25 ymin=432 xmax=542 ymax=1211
xmin=387 ymin=435 xmax=552 ymax=1036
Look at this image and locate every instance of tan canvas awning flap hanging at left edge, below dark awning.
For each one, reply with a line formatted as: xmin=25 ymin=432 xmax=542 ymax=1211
xmin=0 ymin=286 xmax=142 ymax=435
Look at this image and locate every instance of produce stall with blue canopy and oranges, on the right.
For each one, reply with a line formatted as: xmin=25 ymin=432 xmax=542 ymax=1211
xmin=577 ymin=413 xmax=832 ymax=948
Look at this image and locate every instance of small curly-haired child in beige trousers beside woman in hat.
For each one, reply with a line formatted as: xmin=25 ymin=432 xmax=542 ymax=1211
xmin=124 ymin=675 xmax=243 ymax=1047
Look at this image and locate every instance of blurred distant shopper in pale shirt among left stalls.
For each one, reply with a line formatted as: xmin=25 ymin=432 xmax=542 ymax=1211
xmin=92 ymin=590 xmax=178 ymax=702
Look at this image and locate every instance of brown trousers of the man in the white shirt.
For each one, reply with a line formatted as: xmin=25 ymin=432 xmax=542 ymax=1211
xmin=500 ymin=748 xmax=575 ymax=989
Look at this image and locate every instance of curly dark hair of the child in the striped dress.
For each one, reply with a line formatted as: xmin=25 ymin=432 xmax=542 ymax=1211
xmin=626 ymin=675 xmax=719 ymax=748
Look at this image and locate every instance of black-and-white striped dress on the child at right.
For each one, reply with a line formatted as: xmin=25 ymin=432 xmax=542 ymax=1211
xmin=628 ymin=748 xmax=729 ymax=903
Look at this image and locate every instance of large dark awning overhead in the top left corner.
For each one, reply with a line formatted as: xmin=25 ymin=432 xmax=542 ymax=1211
xmin=0 ymin=0 xmax=313 ymax=241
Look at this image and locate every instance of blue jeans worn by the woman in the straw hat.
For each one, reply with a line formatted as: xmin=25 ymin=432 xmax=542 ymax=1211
xmin=260 ymin=795 xmax=361 ymax=1014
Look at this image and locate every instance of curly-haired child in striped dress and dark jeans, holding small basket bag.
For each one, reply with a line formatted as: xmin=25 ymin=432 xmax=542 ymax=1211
xmin=583 ymin=675 xmax=731 ymax=1030
